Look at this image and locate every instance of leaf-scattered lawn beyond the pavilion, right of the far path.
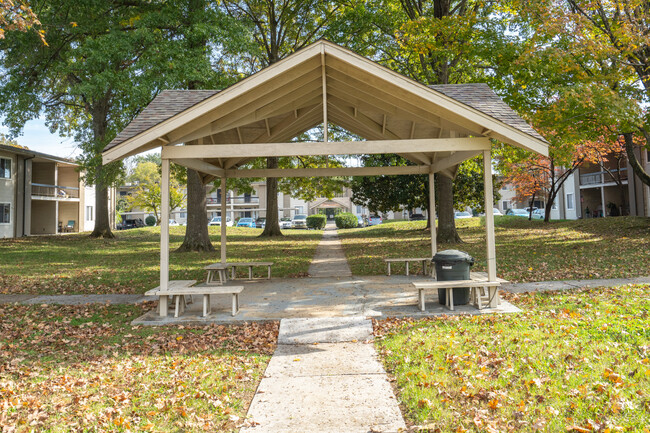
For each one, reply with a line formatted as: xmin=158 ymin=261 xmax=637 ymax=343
xmin=339 ymin=217 xmax=650 ymax=282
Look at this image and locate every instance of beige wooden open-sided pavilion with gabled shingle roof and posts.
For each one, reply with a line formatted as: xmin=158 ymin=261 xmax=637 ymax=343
xmin=103 ymin=40 xmax=548 ymax=304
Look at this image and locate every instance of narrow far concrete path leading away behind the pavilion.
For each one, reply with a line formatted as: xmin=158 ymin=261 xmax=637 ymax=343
xmin=309 ymin=223 xmax=352 ymax=278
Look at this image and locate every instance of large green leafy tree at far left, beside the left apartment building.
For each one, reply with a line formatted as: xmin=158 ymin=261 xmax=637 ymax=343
xmin=0 ymin=0 xmax=184 ymax=238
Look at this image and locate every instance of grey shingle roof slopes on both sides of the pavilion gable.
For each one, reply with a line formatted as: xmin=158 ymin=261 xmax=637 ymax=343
xmin=104 ymin=83 xmax=546 ymax=151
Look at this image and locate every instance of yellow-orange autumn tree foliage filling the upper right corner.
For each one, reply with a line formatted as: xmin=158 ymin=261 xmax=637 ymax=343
xmin=519 ymin=0 xmax=650 ymax=185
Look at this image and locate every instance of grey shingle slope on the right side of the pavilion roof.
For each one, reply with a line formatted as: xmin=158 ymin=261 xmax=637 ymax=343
xmin=429 ymin=83 xmax=546 ymax=143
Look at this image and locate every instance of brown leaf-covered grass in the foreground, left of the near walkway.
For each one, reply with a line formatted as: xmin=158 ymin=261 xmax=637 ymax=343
xmin=0 ymin=305 xmax=278 ymax=433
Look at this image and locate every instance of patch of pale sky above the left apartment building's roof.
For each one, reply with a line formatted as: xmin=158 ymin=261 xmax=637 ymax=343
xmin=0 ymin=118 xmax=80 ymax=158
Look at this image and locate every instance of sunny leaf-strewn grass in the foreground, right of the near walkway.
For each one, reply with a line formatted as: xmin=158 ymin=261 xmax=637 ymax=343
xmin=375 ymin=285 xmax=650 ymax=433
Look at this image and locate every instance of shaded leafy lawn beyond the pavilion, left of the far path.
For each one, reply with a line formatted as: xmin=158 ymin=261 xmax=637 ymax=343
xmin=0 ymin=227 xmax=322 ymax=294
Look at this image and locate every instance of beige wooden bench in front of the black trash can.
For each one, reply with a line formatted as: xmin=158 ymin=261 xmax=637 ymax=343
xmin=413 ymin=272 xmax=508 ymax=311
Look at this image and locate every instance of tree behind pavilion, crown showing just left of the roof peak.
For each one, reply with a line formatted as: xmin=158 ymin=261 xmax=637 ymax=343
xmin=223 ymin=0 xmax=337 ymax=237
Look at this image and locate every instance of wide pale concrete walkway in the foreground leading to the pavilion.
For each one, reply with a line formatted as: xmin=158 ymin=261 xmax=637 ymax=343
xmin=240 ymin=317 xmax=406 ymax=433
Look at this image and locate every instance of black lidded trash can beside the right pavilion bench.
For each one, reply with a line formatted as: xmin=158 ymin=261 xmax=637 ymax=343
xmin=431 ymin=250 xmax=474 ymax=305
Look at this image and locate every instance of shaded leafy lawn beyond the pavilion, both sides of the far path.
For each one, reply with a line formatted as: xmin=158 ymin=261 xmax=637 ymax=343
xmin=0 ymin=217 xmax=650 ymax=294
